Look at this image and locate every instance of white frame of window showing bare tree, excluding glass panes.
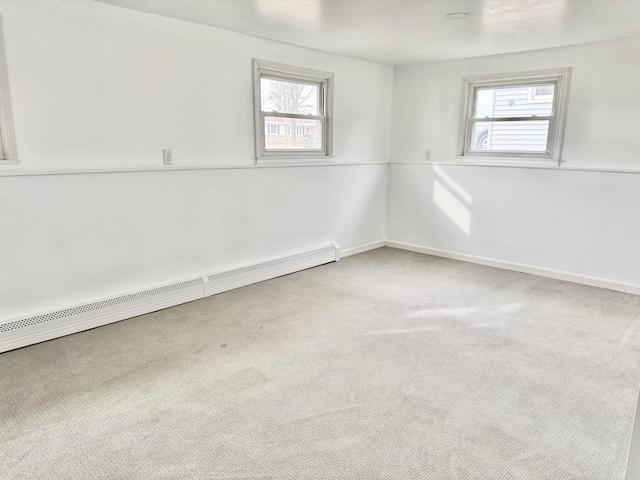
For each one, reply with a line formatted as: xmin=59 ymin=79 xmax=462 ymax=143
xmin=253 ymin=59 xmax=333 ymax=163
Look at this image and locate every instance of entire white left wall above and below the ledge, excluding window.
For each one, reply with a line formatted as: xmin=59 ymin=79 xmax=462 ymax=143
xmin=0 ymin=0 xmax=393 ymax=320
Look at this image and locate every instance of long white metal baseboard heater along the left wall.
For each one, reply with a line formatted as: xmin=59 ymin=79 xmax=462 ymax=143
xmin=0 ymin=245 xmax=340 ymax=353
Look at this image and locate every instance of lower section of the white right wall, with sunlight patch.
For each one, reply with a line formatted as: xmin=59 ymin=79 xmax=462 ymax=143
xmin=386 ymin=164 xmax=640 ymax=291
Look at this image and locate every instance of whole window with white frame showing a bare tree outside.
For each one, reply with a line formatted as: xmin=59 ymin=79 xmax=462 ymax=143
xmin=254 ymin=60 xmax=333 ymax=160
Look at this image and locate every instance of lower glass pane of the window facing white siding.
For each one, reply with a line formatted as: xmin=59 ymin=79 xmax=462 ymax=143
xmin=469 ymin=120 xmax=549 ymax=153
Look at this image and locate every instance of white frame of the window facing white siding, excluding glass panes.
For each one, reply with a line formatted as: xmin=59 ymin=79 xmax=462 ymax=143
xmin=458 ymin=67 xmax=571 ymax=165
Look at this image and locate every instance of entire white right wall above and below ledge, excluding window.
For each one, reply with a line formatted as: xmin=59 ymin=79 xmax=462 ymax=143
xmin=386 ymin=37 xmax=640 ymax=288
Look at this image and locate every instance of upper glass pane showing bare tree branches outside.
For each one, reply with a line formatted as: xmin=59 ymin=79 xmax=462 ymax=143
xmin=260 ymin=77 xmax=321 ymax=115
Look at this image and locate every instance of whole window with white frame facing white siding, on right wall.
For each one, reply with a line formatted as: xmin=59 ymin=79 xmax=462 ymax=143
xmin=460 ymin=68 xmax=571 ymax=162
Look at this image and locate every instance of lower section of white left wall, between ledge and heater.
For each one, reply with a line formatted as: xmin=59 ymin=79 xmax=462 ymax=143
xmin=0 ymin=164 xmax=387 ymax=319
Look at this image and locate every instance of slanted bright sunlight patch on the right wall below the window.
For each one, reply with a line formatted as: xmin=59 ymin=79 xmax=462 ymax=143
xmin=433 ymin=165 xmax=473 ymax=235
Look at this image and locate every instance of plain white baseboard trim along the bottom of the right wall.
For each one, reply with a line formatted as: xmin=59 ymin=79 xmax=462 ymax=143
xmin=385 ymin=240 xmax=640 ymax=295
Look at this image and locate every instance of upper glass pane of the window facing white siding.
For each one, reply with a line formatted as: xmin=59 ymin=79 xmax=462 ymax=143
xmin=473 ymin=84 xmax=555 ymax=118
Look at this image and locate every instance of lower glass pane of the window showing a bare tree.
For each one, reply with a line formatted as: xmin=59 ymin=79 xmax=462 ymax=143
xmin=264 ymin=116 xmax=322 ymax=150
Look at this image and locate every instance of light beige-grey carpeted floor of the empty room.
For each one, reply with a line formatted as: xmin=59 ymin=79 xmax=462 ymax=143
xmin=0 ymin=248 xmax=640 ymax=480
